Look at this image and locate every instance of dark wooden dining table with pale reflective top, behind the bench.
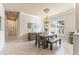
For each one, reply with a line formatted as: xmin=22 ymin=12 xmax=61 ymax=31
xmin=40 ymin=34 xmax=57 ymax=49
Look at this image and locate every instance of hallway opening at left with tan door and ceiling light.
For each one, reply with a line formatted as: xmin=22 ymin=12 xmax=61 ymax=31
xmin=5 ymin=11 xmax=19 ymax=42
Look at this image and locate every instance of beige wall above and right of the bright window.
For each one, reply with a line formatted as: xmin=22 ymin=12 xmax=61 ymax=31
xmin=52 ymin=9 xmax=76 ymax=39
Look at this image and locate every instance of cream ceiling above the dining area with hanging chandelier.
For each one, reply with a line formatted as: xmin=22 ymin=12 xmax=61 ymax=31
xmin=3 ymin=3 xmax=74 ymax=17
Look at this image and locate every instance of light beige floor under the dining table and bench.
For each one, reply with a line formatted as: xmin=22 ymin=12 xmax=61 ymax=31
xmin=0 ymin=37 xmax=73 ymax=55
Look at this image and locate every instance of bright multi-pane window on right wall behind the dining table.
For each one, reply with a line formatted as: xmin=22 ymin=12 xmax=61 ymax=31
xmin=51 ymin=19 xmax=64 ymax=35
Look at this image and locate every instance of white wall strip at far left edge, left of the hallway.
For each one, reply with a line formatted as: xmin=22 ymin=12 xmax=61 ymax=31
xmin=0 ymin=4 xmax=5 ymax=50
